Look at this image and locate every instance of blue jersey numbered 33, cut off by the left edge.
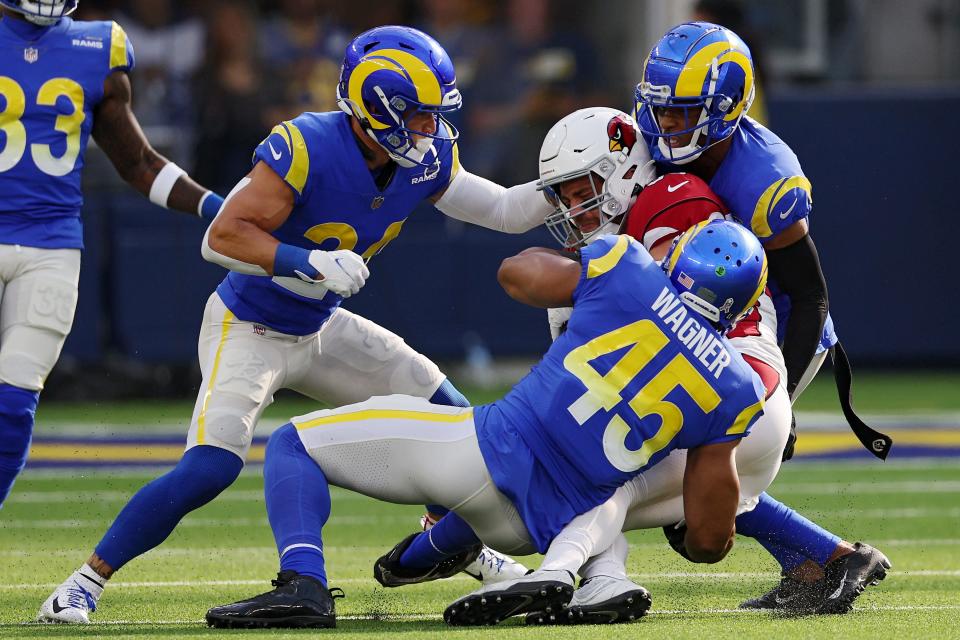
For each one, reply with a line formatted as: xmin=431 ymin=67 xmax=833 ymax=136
xmin=0 ymin=18 xmax=133 ymax=249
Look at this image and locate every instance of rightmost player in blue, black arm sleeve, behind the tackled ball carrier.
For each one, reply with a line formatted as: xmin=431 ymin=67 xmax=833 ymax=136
xmin=635 ymin=22 xmax=892 ymax=609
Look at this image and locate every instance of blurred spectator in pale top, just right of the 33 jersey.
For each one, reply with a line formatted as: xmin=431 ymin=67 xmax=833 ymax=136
xmin=117 ymin=0 xmax=205 ymax=164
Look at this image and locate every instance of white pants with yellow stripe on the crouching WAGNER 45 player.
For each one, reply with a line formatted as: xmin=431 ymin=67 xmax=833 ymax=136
xmin=291 ymin=395 xmax=535 ymax=554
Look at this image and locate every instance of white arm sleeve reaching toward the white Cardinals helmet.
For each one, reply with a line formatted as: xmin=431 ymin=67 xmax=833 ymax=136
xmin=436 ymin=168 xmax=553 ymax=233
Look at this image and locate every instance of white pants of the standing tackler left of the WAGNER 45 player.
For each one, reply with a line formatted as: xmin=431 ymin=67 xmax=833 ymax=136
xmin=187 ymin=293 xmax=444 ymax=459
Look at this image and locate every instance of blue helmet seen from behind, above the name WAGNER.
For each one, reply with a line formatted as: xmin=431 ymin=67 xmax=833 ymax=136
xmin=662 ymin=219 xmax=767 ymax=331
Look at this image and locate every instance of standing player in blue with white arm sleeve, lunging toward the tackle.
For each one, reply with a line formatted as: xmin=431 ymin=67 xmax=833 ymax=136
xmin=39 ymin=26 xmax=551 ymax=623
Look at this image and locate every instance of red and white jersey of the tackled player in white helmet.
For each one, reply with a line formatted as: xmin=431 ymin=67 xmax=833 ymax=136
xmin=625 ymin=173 xmax=787 ymax=392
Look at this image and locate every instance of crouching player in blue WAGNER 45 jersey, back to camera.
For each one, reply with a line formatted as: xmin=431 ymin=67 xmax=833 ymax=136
xmin=207 ymin=220 xmax=767 ymax=627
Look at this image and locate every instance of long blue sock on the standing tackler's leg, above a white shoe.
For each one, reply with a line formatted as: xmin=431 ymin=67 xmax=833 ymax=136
xmin=95 ymin=445 xmax=243 ymax=571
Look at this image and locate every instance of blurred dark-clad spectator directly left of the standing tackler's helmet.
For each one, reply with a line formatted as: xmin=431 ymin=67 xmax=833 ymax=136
xmin=193 ymin=1 xmax=285 ymax=193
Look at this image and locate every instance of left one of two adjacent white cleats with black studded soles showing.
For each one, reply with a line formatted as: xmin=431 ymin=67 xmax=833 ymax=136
xmin=443 ymin=571 xmax=573 ymax=626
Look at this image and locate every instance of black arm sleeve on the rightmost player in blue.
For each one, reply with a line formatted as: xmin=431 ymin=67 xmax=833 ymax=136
xmin=767 ymin=234 xmax=828 ymax=395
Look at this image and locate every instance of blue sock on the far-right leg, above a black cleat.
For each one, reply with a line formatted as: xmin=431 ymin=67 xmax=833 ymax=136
xmin=737 ymin=493 xmax=840 ymax=572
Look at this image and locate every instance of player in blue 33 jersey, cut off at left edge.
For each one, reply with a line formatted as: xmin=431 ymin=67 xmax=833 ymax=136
xmin=0 ymin=0 xmax=223 ymax=506
